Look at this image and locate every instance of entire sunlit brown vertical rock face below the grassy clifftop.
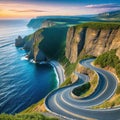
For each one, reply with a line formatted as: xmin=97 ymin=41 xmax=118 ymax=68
xmin=66 ymin=27 xmax=120 ymax=63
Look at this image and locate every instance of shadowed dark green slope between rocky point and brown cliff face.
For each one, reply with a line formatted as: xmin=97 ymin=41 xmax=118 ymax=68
xmin=38 ymin=27 xmax=68 ymax=60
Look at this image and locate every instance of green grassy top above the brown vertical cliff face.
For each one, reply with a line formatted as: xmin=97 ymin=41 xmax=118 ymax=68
xmin=76 ymin=22 xmax=120 ymax=29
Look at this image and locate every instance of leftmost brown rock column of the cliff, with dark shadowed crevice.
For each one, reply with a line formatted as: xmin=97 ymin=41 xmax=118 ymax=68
xmin=66 ymin=27 xmax=86 ymax=62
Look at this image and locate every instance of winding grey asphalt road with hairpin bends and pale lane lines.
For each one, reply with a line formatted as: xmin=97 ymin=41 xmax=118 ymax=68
xmin=45 ymin=59 xmax=120 ymax=120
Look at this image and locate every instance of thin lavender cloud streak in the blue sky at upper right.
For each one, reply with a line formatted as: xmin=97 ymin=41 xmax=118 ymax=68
xmin=85 ymin=3 xmax=120 ymax=9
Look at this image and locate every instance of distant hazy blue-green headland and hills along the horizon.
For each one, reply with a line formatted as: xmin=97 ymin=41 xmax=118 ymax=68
xmin=27 ymin=10 xmax=120 ymax=29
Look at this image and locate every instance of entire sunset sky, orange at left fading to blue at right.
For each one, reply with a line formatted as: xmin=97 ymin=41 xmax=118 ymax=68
xmin=0 ymin=0 xmax=120 ymax=19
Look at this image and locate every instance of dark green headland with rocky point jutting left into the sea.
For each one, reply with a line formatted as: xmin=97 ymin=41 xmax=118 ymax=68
xmin=15 ymin=27 xmax=68 ymax=62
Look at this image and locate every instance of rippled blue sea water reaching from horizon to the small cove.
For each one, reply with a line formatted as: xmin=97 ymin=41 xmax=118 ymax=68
xmin=0 ymin=20 xmax=58 ymax=114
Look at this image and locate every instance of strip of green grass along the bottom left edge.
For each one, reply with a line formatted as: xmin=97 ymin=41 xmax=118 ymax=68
xmin=0 ymin=113 xmax=58 ymax=120
